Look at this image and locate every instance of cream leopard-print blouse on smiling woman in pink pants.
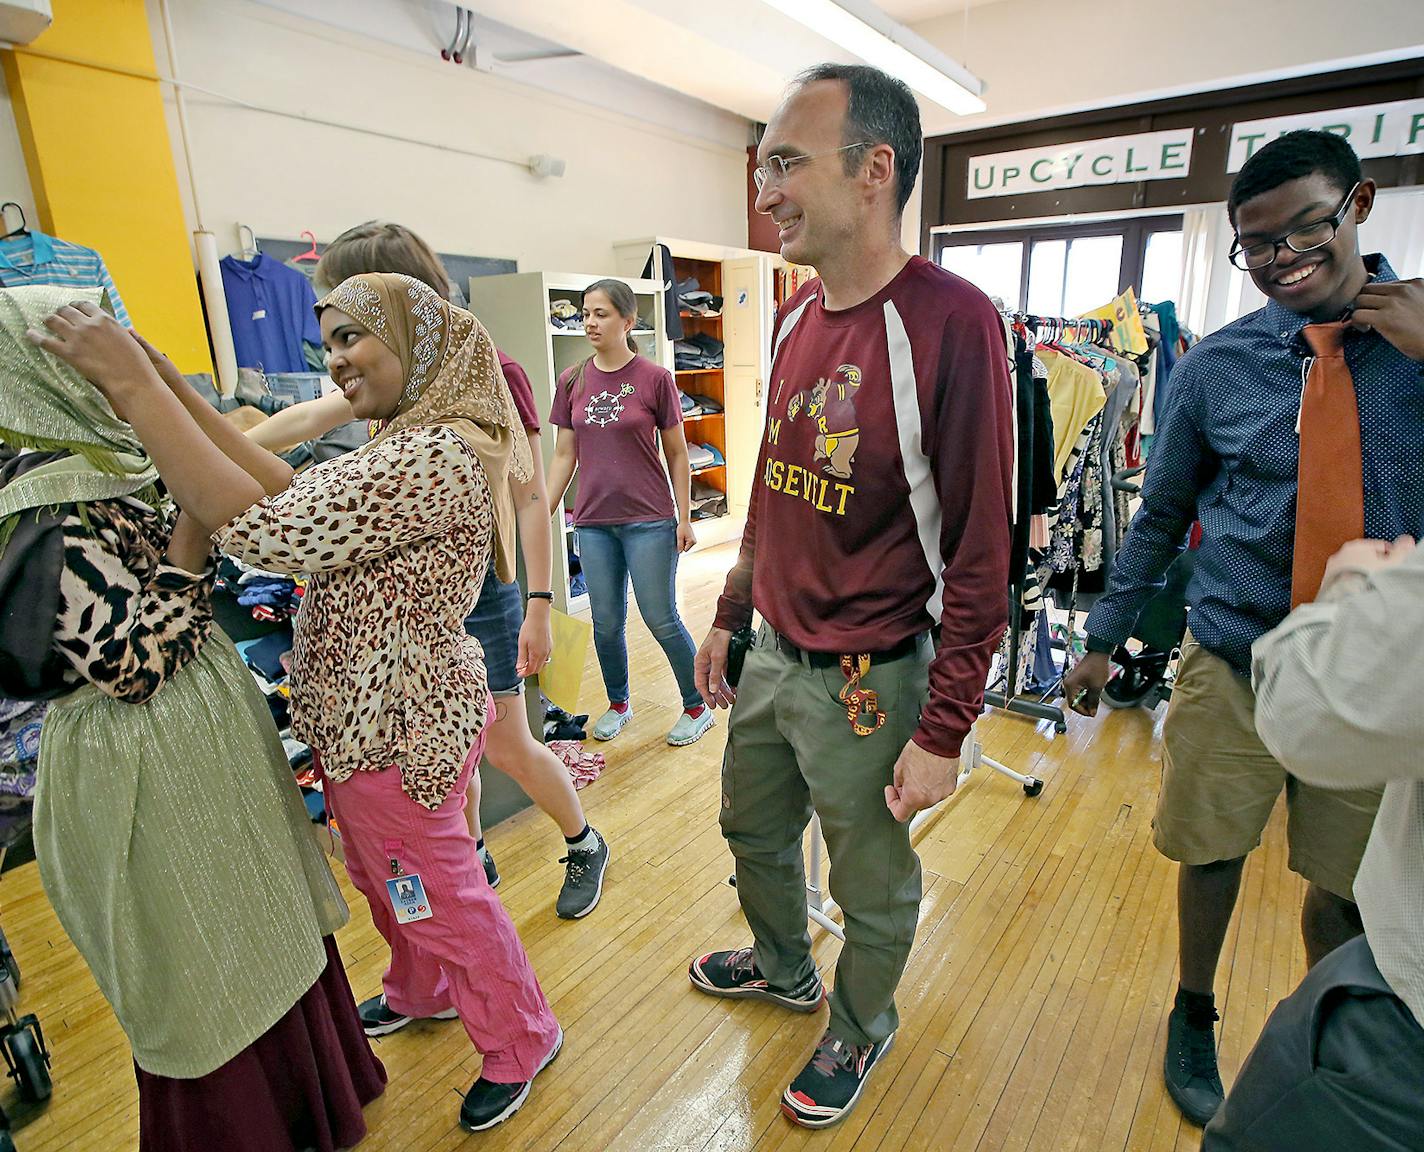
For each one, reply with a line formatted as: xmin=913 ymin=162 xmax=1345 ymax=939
xmin=216 ymin=424 xmax=494 ymax=809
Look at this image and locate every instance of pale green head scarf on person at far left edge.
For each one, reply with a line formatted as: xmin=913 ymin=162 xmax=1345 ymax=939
xmin=0 ymin=286 xmax=158 ymax=547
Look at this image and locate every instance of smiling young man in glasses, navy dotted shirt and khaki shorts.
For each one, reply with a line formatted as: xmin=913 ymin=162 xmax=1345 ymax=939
xmin=1064 ymin=132 xmax=1424 ymax=1124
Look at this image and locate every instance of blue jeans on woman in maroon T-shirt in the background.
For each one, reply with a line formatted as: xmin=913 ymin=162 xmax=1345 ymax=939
xmin=578 ymin=520 xmax=702 ymax=708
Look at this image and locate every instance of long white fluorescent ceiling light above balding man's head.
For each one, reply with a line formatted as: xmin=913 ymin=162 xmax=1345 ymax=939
xmin=763 ymin=0 xmax=987 ymax=115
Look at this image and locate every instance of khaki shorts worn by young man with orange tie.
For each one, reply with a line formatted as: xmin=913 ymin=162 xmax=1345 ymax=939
xmin=1152 ymin=632 xmax=1383 ymax=900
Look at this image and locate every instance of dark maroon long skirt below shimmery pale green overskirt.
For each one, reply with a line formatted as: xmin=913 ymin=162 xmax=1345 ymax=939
xmin=134 ymin=936 xmax=386 ymax=1152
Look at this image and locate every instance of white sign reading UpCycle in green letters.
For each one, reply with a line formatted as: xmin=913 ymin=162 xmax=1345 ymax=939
xmin=967 ymin=128 xmax=1192 ymax=199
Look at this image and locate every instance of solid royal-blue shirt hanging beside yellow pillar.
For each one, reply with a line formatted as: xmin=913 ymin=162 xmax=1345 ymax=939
xmin=221 ymin=252 xmax=322 ymax=373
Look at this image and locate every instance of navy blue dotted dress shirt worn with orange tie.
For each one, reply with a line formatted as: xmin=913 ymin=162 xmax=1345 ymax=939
xmin=1087 ymin=255 xmax=1424 ymax=676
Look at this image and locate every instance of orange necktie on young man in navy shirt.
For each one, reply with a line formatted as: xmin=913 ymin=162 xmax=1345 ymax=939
xmin=1290 ymin=323 xmax=1364 ymax=608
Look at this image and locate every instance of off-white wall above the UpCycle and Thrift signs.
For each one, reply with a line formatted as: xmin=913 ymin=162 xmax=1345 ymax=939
xmin=914 ymin=0 xmax=1424 ymax=135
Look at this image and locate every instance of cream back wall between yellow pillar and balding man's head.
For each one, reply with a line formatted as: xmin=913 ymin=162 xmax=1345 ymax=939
xmin=151 ymin=0 xmax=746 ymax=272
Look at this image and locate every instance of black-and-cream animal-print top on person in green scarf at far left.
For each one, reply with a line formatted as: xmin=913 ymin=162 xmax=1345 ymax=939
xmin=54 ymin=500 xmax=212 ymax=703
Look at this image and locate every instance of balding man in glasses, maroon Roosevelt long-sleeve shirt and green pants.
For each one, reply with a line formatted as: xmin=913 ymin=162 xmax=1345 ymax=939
xmin=689 ymin=66 xmax=1011 ymax=1128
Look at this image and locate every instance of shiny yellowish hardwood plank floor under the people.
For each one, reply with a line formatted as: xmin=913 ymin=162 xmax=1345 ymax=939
xmin=0 ymin=548 xmax=1304 ymax=1152
